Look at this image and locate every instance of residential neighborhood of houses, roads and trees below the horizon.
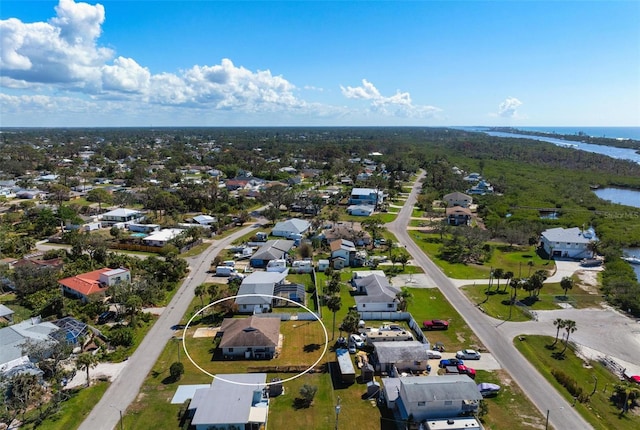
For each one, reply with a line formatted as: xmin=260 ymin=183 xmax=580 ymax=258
xmin=0 ymin=128 xmax=640 ymax=430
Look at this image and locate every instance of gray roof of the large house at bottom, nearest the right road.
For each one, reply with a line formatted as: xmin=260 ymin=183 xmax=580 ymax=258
xmin=400 ymin=375 xmax=482 ymax=403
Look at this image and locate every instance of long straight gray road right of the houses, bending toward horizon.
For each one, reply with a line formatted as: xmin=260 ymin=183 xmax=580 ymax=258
xmin=388 ymin=172 xmax=593 ymax=429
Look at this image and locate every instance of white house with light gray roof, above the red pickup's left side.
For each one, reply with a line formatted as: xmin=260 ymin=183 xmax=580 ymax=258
xmin=351 ymin=272 xmax=400 ymax=312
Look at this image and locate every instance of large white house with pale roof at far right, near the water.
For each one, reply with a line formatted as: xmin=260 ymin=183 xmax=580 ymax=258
xmin=540 ymin=227 xmax=598 ymax=259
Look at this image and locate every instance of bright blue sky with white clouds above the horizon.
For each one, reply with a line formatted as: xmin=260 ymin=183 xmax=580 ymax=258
xmin=0 ymin=0 xmax=640 ymax=127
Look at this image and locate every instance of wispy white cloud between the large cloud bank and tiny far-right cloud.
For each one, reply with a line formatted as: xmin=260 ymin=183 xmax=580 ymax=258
xmin=340 ymin=79 xmax=440 ymax=118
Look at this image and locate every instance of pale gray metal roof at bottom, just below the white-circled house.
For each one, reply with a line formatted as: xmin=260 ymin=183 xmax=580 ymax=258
xmin=190 ymin=373 xmax=264 ymax=425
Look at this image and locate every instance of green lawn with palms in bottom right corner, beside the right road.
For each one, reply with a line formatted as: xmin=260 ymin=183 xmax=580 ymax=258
xmin=514 ymin=336 xmax=640 ymax=430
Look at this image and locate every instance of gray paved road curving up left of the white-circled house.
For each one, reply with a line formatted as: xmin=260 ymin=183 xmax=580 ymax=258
xmin=79 ymin=224 xmax=260 ymax=430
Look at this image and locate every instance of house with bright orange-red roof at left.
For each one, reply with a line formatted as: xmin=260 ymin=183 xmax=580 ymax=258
xmin=58 ymin=267 xmax=131 ymax=302
